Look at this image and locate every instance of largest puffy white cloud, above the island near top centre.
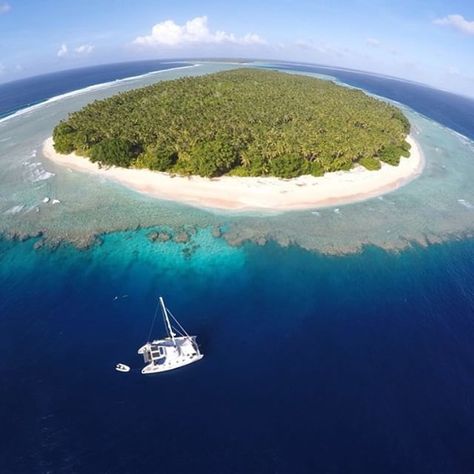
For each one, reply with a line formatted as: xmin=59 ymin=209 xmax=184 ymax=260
xmin=133 ymin=16 xmax=266 ymax=46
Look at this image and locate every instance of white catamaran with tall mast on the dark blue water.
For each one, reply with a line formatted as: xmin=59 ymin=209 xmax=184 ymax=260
xmin=138 ymin=296 xmax=204 ymax=374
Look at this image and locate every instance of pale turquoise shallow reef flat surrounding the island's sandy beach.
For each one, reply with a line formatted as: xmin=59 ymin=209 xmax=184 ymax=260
xmin=0 ymin=63 xmax=474 ymax=253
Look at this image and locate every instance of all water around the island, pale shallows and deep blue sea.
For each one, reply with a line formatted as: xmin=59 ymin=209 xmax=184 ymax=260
xmin=0 ymin=64 xmax=474 ymax=474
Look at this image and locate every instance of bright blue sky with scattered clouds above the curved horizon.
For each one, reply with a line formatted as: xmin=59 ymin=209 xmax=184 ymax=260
xmin=0 ymin=0 xmax=474 ymax=96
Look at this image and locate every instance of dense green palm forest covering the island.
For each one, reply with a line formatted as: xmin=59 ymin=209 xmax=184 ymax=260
xmin=53 ymin=68 xmax=410 ymax=178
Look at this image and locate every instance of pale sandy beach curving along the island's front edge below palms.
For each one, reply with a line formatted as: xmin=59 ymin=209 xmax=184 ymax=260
xmin=43 ymin=135 xmax=424 ymax=211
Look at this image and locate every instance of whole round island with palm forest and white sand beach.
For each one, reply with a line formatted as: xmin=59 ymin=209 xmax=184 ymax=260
xmin=44 ymin=68 xmax=423 ymax=209
